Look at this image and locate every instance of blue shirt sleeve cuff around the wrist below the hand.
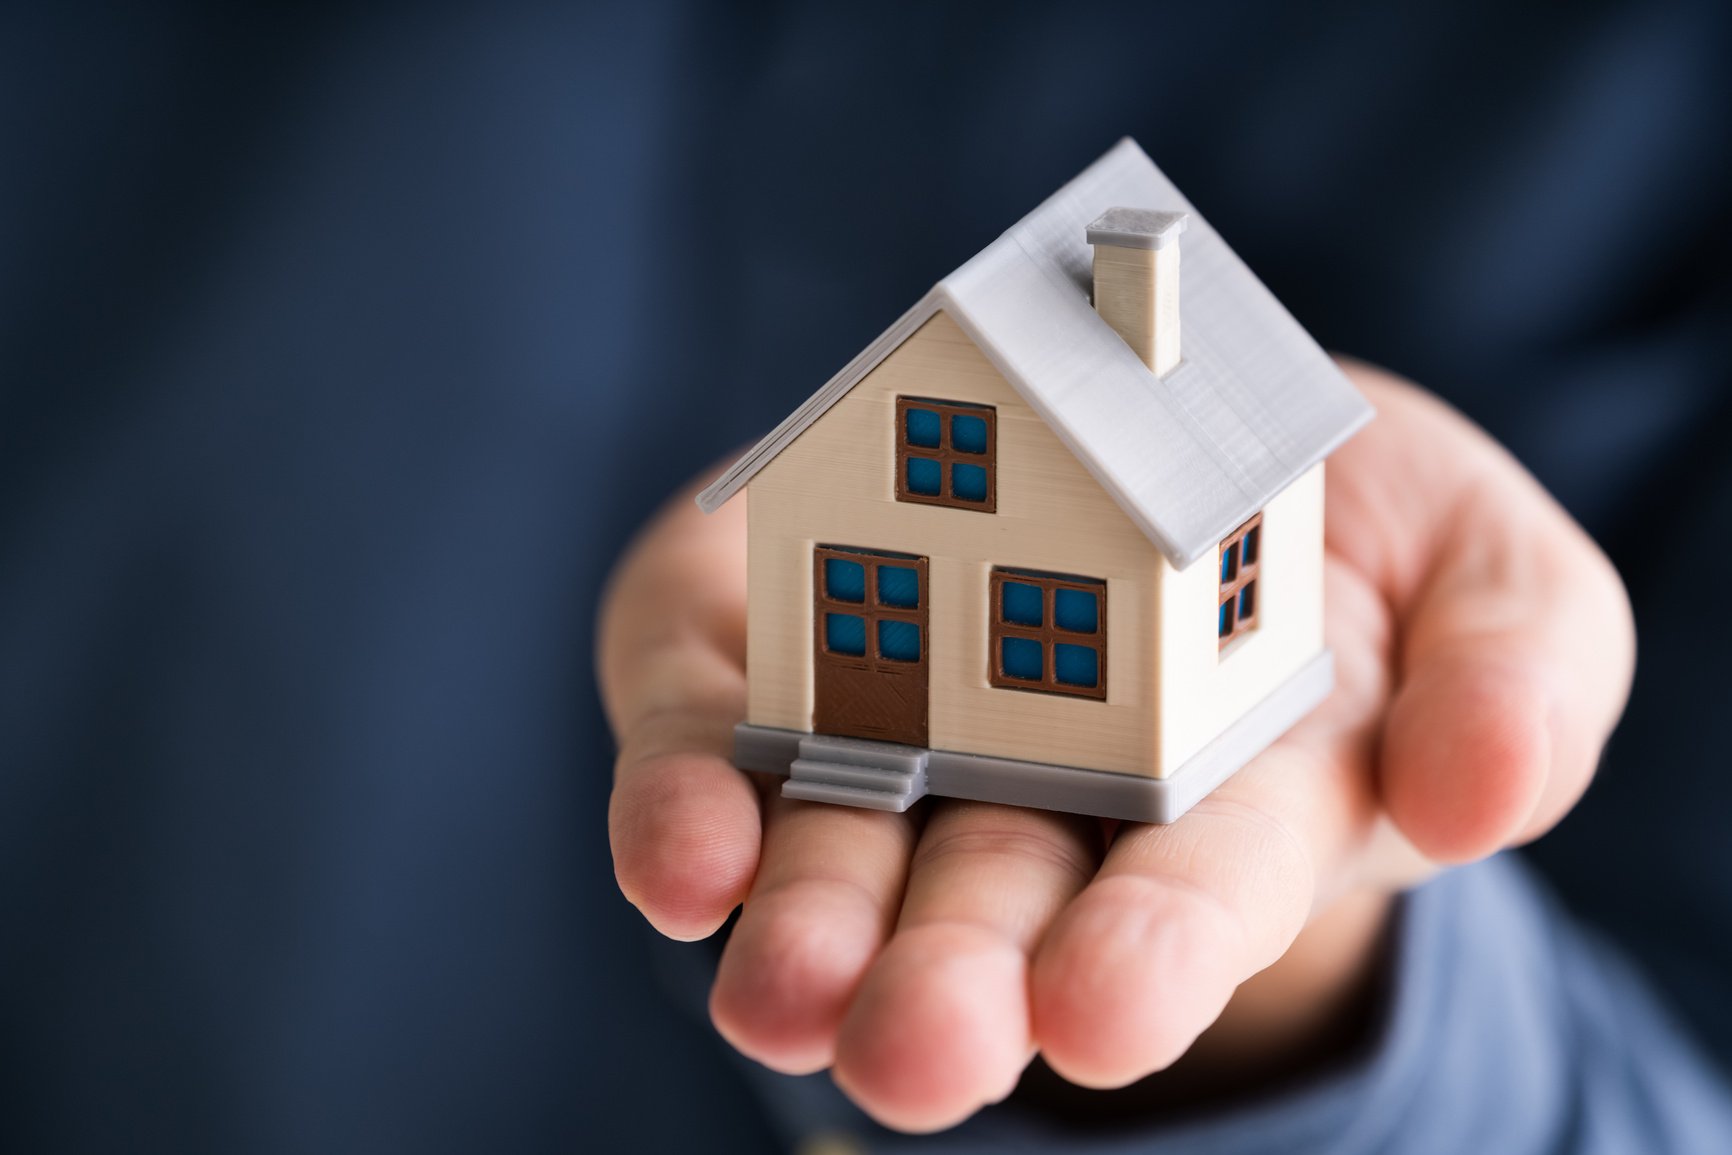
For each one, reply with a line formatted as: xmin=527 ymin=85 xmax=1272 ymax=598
xmin=713 ymin=855 xmax=1732 ymax=1155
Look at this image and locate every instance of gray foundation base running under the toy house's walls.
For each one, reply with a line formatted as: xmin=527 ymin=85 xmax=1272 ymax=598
xmin=734 ymin=649 xmax=1335 ymax=823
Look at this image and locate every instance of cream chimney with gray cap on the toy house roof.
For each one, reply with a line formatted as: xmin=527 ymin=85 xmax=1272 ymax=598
xmin=1088 ymin=208 xmax=1190 ymax=376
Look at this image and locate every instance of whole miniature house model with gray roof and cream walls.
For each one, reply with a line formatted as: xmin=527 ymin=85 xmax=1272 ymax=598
xmin=698 ymin=140 xmax=1372 ymax=823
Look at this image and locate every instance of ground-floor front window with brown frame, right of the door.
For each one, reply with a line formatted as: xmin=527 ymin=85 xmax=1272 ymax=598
xmin=987 ymin=568 xmax=1107 ymax=701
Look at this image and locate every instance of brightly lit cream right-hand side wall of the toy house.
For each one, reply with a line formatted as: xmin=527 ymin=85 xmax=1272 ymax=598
xmin=1160 ymin=464 xmax=1323 ymax=776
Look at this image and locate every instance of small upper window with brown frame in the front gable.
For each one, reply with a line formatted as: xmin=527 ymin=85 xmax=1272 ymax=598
xmin=895 ymin=397 xmax=998 ymax=513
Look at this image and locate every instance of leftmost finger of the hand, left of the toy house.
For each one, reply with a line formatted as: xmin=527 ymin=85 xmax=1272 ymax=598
xmin=598 ymin=477 xmax=762 ymax=939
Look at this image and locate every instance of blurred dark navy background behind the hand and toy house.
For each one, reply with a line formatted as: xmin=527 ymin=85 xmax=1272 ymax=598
xmin=0 ymin=0 xmax=1732 ymax=1152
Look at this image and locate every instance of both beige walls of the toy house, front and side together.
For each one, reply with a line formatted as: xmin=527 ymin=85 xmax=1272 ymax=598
xmin=746 ymin=312 xmax=1322 ymax=776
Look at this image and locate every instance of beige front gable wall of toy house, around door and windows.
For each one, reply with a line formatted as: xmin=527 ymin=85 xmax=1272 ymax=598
xmin=746 ymin=312 xmax=1167 ymax=774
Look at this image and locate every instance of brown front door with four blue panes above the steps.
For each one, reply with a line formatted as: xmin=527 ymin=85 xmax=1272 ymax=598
xmin=812 ymin=545 xmax=930 ymax=746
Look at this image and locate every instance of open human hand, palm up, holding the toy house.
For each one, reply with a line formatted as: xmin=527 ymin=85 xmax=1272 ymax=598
xmin=599 ymin=364 xmax=1633 ymax=1131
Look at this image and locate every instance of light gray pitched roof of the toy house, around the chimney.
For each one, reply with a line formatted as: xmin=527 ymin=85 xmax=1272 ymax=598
xmin=698 ymin=139 xmax=1372 ymax=568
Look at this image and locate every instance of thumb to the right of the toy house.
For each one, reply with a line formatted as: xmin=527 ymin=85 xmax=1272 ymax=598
xmin=1337 ymin=371 xmax=1635 ymax=862
